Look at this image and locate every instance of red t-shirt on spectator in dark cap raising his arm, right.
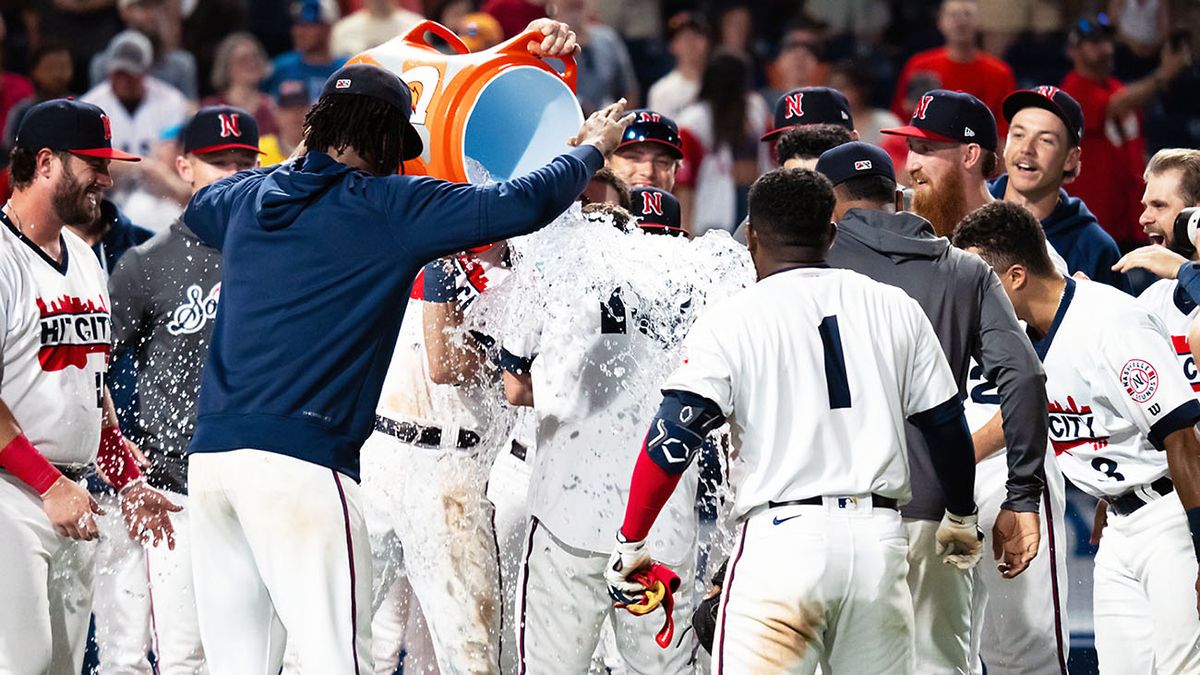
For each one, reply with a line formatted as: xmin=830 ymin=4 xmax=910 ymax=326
xmin=1061 ymin=71 xmax=1146 ymax=245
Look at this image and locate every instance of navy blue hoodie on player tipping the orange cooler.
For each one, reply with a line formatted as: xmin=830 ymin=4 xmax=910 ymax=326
xmin=184 ymin=145 xmax=604 ymax=480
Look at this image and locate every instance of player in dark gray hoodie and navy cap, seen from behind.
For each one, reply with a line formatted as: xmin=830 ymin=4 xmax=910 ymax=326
xmin=811 ymin=141 xmax=1066 ymax=673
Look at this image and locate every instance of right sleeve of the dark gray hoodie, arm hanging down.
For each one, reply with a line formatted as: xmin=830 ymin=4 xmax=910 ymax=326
xmin=979 ymin=270 xmax=1046 ymax=513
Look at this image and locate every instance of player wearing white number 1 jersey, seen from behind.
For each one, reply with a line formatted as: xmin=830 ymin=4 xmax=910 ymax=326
xmin=605 ymin=169 xmax=982 ymax=674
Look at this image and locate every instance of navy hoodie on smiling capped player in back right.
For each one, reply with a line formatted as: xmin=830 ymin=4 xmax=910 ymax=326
xmin=988 ymin=173 xmax=1133 ymax=293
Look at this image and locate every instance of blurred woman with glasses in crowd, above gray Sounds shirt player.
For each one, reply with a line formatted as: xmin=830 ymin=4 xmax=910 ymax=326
xmin=200 ymin=32 xmax=278 ymax=135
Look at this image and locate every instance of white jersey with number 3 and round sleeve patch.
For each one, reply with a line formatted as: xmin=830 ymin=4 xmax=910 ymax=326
xmin=1033 ymin=279 xmax=1200 ymax=497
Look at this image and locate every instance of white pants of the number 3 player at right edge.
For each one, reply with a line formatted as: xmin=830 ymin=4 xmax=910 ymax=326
xmin=1092 ymin=492 xmax=1200 ymax=675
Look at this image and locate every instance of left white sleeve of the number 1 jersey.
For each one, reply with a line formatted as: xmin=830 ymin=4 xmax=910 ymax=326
xmin=662 ymin=306 xmax=734 ymax=417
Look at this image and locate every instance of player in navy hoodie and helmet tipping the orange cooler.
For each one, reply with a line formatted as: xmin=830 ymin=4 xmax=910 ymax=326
xmin=184 ymin=36 xmax=629 ymax=674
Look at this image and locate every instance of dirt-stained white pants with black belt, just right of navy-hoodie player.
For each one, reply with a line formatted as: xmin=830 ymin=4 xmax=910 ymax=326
xmin=361 ymin=432 xmax=502 ymax=675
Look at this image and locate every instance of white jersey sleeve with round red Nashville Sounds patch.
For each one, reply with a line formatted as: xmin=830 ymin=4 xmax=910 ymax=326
xmin=1096 ymin=313 xmax=1200 ymax=447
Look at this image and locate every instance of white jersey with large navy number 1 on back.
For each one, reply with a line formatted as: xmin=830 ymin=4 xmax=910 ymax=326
xmin=664 ymin=268 xmax=958 ymax=518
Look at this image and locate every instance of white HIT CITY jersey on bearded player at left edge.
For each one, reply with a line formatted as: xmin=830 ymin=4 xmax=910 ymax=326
xmin=0 ymin=214 xmax=112 ymax=464
